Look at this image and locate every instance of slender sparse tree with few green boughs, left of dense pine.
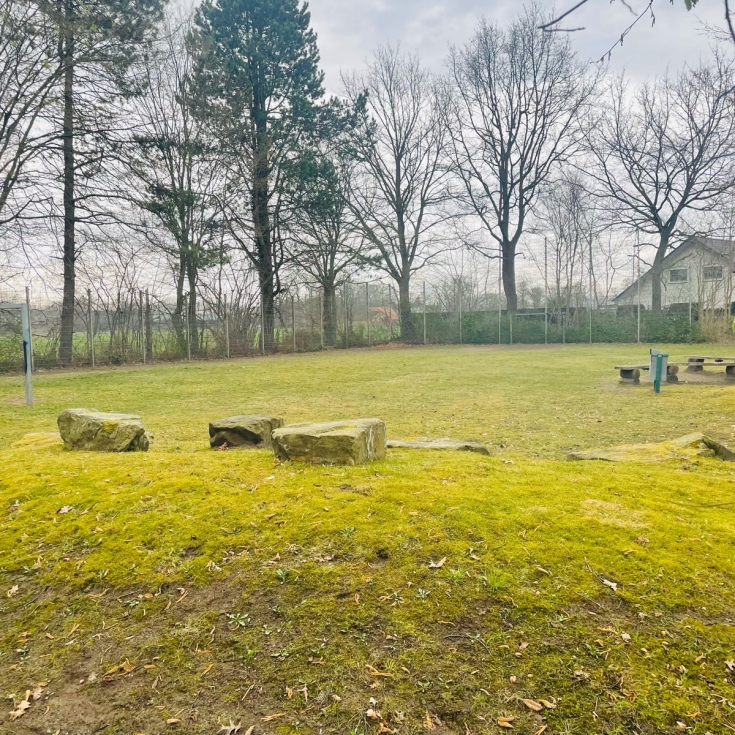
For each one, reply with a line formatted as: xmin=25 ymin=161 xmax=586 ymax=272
xmin=123 ymin=19 xmax=226 ymax=360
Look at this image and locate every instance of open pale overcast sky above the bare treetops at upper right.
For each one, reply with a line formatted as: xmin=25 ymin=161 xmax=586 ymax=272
xmin=309 ymin=0 xmax=723 ymax=92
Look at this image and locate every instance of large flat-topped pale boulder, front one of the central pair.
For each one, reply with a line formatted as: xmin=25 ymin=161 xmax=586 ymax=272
xmin=273 ymin=419 xmax=387 ymax=465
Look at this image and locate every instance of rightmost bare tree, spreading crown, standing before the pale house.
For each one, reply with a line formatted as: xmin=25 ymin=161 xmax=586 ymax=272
xmin=588 ymin=55 xmax=735 ymax=312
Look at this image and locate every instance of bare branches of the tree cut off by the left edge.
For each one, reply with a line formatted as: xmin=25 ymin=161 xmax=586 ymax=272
xmin=0 ymin=0 xmax=61 ymax=224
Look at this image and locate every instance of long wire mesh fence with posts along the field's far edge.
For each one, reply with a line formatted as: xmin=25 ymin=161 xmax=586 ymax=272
xmin=0 ymin=281 xmax=733 ymax=372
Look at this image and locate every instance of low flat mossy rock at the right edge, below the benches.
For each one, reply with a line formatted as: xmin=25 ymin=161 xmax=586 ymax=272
xmin=567 ymin=433 xmax=735 ymax=462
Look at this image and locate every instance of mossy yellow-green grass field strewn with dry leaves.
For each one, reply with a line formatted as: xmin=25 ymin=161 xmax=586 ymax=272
xmin=0 ymin=346 xmax=735 ymax=735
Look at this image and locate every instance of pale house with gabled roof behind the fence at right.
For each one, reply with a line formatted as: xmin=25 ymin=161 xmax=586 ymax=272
xmin=614 ymin=236 xmax=735 ymax=313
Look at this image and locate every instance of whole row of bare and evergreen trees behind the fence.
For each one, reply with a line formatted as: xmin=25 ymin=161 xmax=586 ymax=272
xmin=0 ymin=0 xmax=735 ymax=364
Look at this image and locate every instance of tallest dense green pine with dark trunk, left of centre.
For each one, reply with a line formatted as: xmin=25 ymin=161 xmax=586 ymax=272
xmin=192 ymin=0 xmax=324 ymax=349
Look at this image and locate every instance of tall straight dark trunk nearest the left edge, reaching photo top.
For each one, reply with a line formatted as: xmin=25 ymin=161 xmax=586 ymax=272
xmin=59 ymin=0 xmax=76 ymax=366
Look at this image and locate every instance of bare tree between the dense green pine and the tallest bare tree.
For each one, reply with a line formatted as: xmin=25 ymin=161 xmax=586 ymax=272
xmin=343 ymin=47 xmax=448 ymax=342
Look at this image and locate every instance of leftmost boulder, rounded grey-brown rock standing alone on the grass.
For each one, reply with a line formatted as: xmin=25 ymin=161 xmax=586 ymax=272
xmin=57 ymin=408 xmax=150 ymax=452
